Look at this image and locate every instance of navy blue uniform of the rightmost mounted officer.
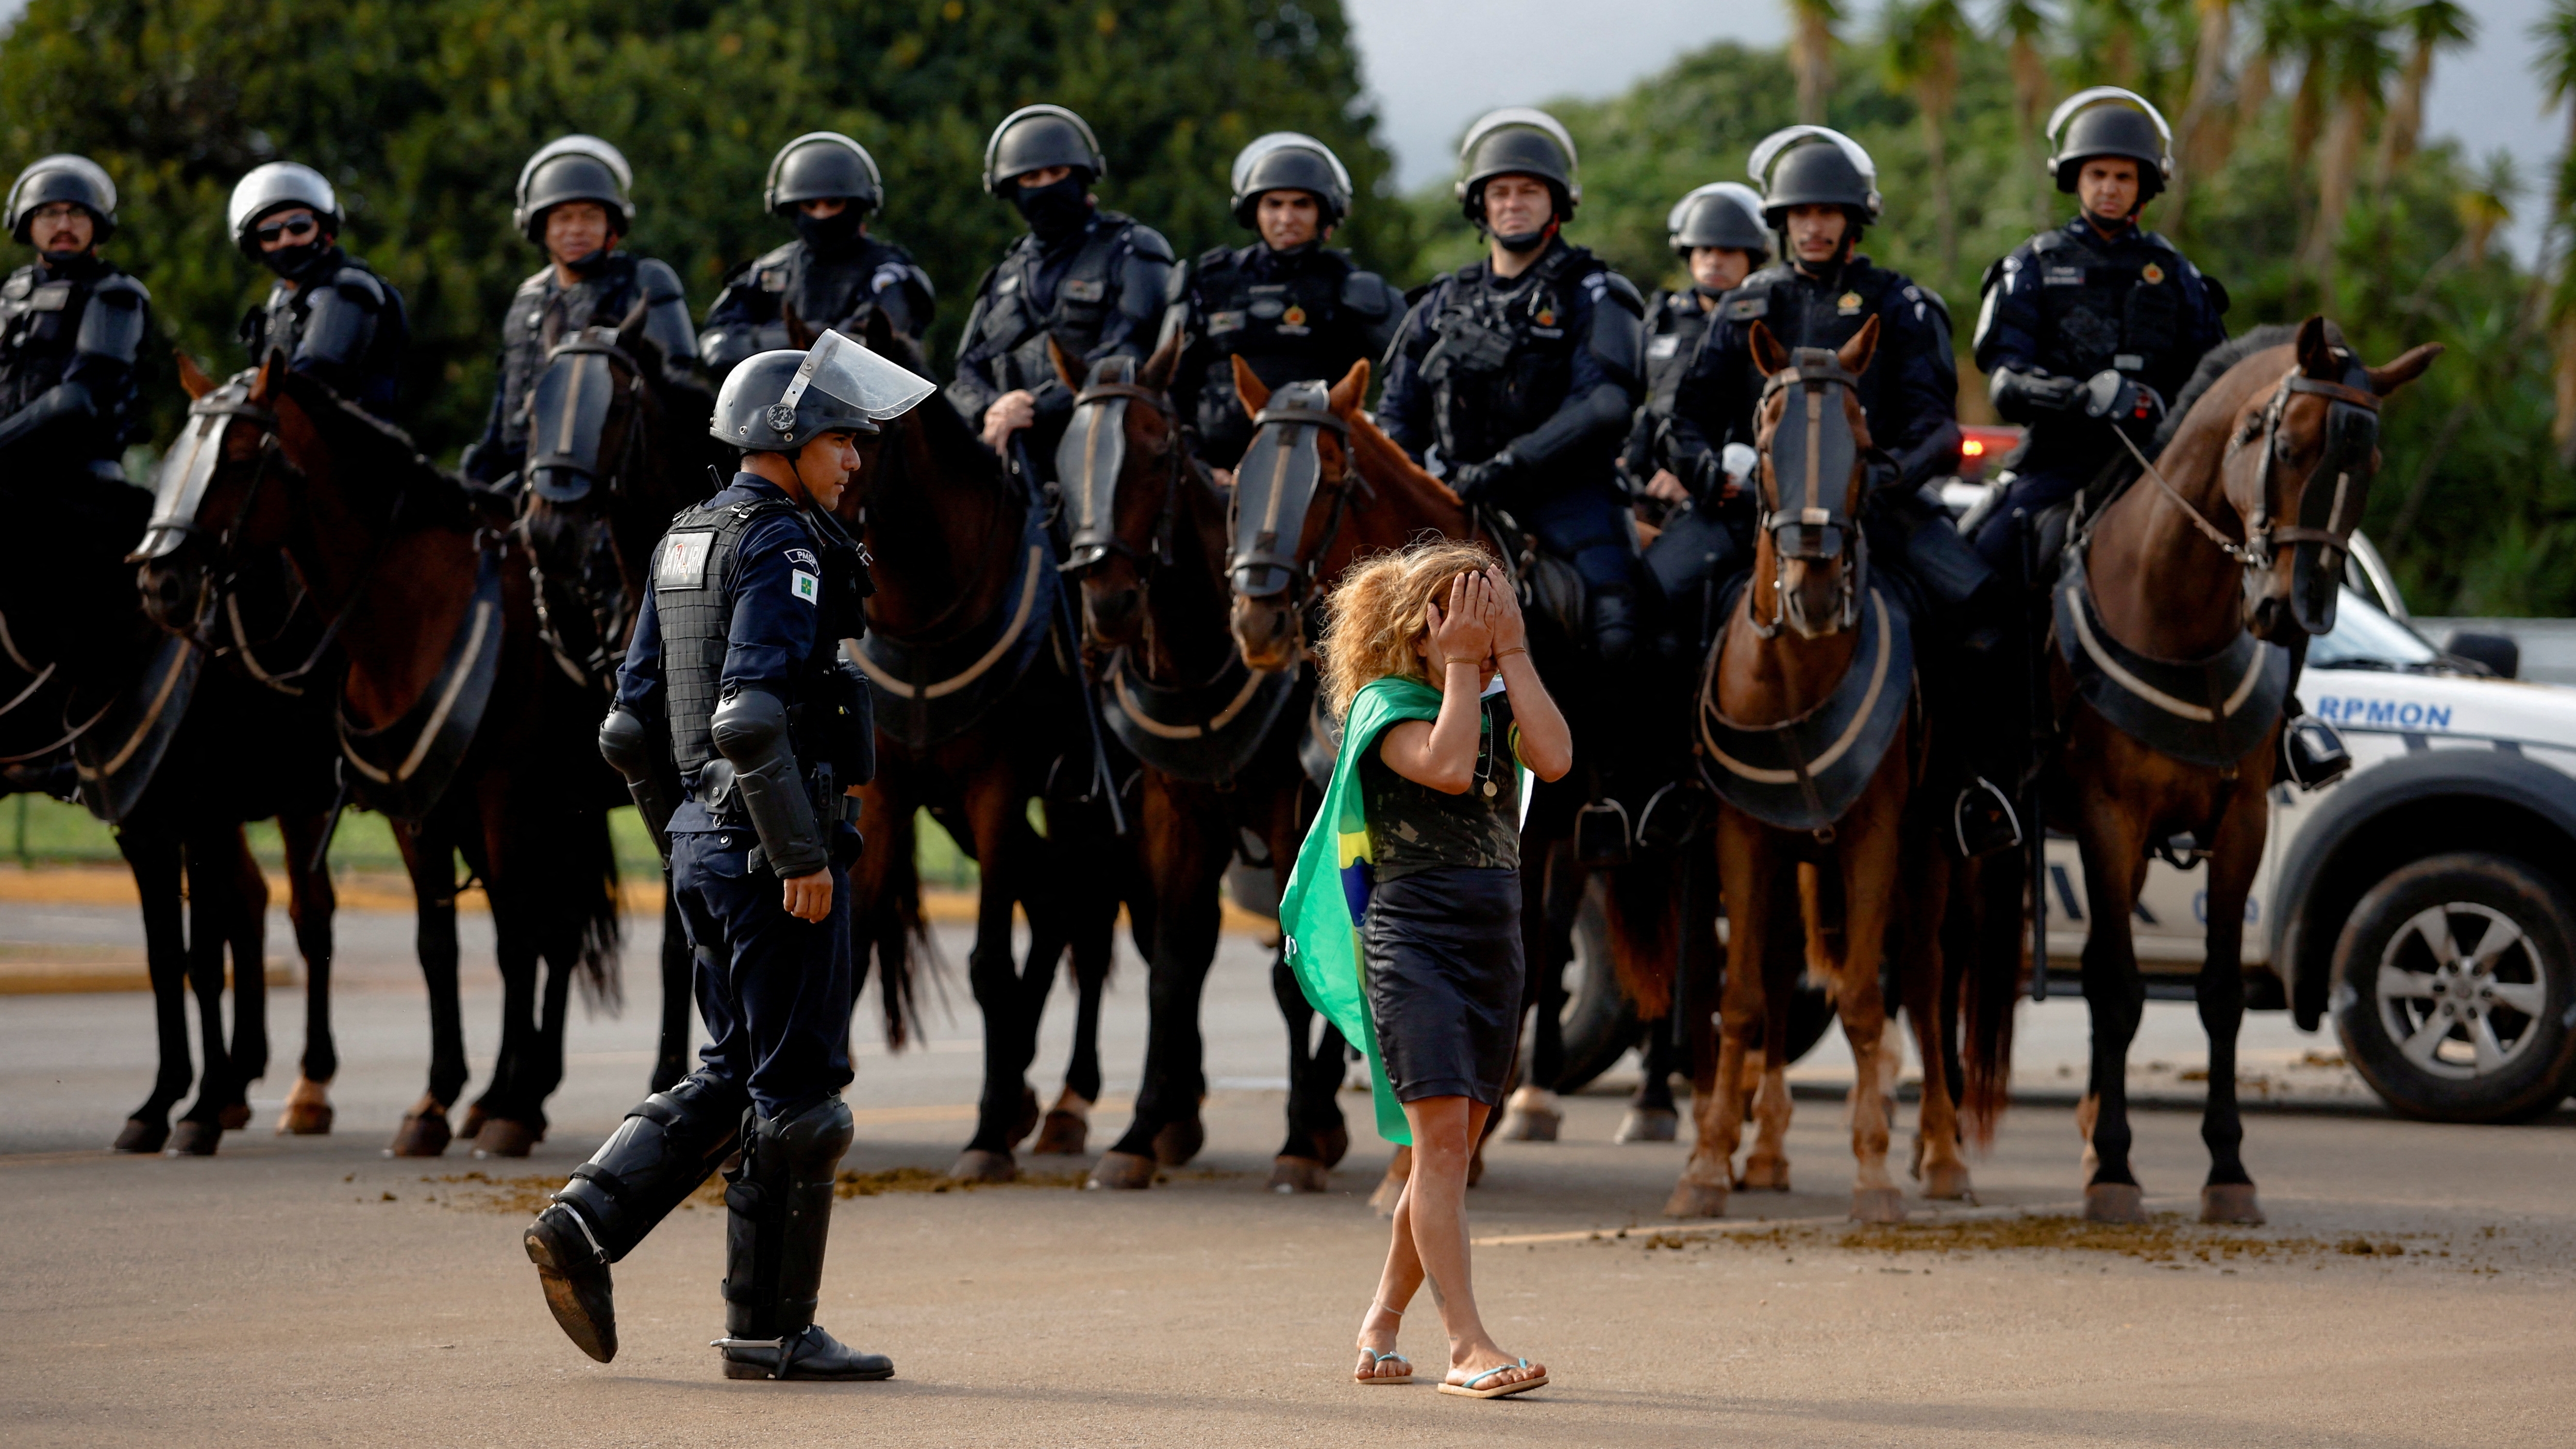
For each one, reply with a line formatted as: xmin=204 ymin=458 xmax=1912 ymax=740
xmin=1976 ymin=216 xmax=2228 ymax=567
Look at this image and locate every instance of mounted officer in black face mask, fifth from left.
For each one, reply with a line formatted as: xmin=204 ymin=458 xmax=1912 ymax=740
xmin=948 ymin=106 xmax=1172 ymax=467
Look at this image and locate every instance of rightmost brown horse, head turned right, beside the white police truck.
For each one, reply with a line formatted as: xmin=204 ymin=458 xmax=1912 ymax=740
xmin=2035 ymin=317 xmax=2442 ymax=1222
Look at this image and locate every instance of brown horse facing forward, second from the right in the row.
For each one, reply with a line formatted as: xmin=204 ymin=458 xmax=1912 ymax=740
xmin=1664 ymin=320 xmax=1968 ymax=1222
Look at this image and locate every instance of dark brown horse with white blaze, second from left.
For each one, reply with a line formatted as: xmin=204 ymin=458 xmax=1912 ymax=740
xmin=137 ymin=351 xmax=618 ymax=1158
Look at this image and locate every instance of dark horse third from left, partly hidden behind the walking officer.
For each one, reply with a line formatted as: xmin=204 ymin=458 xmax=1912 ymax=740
xmin=518 ymin=302 xmax=731 ymax=1091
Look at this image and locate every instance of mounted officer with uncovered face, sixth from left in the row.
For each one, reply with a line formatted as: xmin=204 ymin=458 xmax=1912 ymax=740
xmin=1162 ymin=131 xmax=1404 ymax=472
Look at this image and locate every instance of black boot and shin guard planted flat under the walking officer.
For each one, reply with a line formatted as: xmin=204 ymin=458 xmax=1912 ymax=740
xmin=713 ymin=1096 xmax=894 ymax=1379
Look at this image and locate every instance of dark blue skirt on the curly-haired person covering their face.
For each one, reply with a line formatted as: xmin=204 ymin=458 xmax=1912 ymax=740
xmin=1360 ymin=867 xmax=1523 ymax=1106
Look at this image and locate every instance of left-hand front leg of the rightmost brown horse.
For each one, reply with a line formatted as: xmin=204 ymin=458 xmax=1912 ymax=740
xmin=2076 ymin=763 xmax=2153 ymax=1222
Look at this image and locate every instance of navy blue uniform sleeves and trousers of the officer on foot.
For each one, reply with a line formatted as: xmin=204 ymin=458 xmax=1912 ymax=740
xmin=618 ymin=472 xmax=850 ymax=1117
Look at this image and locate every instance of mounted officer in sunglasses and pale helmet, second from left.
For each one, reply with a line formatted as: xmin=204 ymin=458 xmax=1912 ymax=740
xmin=227 ymin=160 xmax=412 ymax=418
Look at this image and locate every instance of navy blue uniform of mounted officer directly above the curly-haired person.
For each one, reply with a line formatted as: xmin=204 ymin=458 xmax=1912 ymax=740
xmin=1378 ymin=237 xmax=1646 ymax=613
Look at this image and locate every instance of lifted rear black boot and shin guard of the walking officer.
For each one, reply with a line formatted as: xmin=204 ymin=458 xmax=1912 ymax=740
xmin=523 ymin=1075 xmax=742 ymax=1364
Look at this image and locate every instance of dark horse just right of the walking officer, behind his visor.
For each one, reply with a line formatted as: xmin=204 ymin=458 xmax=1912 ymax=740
xmin=840 ymin=314 xmax=1118 ymax=1181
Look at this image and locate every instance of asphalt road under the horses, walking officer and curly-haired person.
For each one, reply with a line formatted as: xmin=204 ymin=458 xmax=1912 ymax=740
xmin=0 ymin=908 xmax=2576 ymax=1446
